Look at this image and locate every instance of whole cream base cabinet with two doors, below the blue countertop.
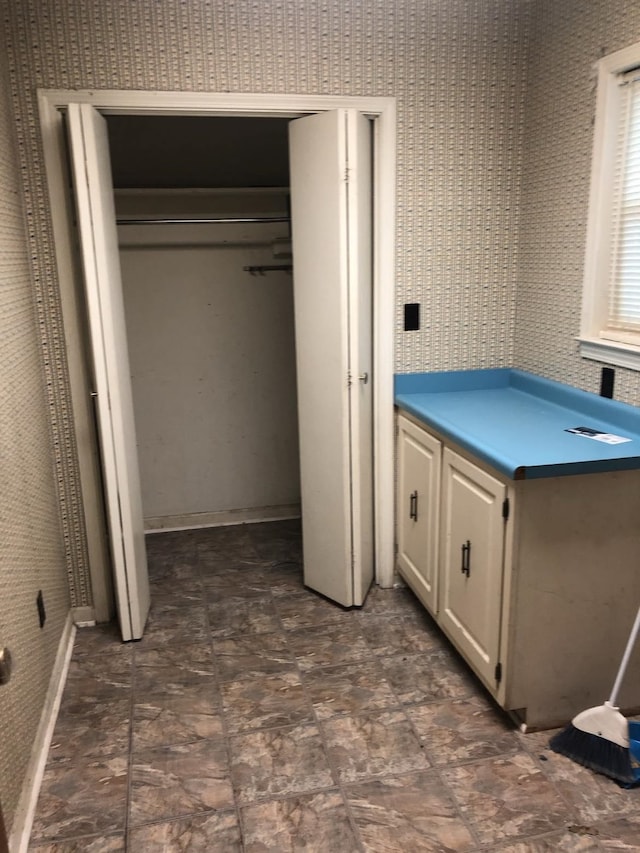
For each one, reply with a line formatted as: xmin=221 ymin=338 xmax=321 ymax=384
xmin=397 ymin=411 xmax=640 ymax=729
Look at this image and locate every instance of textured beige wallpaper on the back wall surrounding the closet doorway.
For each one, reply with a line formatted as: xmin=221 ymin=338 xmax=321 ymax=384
xmin=5 ymin=0 xmax=530 ymax=616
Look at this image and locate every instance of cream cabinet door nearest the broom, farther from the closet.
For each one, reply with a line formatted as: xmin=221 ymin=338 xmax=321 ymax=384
xmin=438 ymin=448 xmax=506 ymax=688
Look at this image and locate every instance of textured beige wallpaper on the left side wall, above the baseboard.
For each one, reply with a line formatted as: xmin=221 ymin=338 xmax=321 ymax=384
xmin=0 ymin=46 xmax=69 ymax=828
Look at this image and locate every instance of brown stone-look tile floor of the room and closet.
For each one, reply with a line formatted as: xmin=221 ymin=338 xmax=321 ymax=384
xmin=30 ymin=522 xmax=640 ymax=853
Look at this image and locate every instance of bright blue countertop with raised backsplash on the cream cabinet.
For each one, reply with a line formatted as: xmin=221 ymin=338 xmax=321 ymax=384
xmin=395 ymin=368 xmax=640 ymax=480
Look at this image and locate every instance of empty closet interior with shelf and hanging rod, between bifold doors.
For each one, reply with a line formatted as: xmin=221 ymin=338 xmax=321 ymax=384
xmin=107 ymin=115 xmax=300 ymax=531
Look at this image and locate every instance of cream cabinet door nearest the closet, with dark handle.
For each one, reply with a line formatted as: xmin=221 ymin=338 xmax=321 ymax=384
xmin=397 ymin=416 xmax=441 ymax=615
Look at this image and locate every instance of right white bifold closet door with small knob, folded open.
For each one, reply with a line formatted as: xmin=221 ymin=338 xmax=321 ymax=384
xmin=289 ymin=109 xmax=374 ymax=606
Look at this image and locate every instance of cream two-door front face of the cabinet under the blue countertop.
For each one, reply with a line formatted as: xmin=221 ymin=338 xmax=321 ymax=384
xmin=397 ymin=415 xmax=507 ymax=689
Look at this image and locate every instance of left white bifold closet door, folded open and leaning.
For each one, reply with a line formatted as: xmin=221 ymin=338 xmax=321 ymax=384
xmin=67 ymin=104 xmax=149 ymax=640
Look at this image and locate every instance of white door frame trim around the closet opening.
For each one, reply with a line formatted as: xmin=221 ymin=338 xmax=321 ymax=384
xmin=38 ymin=89 xmax=396 ymax=604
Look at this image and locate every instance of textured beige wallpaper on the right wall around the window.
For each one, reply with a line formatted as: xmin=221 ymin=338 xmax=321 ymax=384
xmin=514 ymin=0 xmax=640 ymax=405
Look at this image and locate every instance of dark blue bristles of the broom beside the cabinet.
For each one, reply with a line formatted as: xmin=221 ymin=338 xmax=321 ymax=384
xmin=549 ymin=724 xmax=639 ymax=786
